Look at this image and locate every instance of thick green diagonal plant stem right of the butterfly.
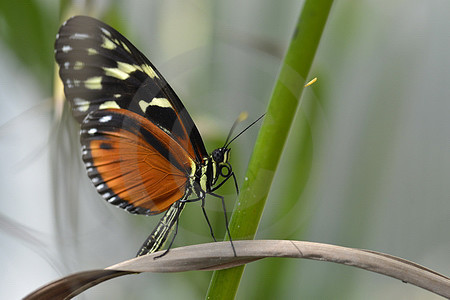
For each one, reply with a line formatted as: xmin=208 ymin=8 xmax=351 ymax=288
xmin=207 ymin=0 xmax=333 ymax=299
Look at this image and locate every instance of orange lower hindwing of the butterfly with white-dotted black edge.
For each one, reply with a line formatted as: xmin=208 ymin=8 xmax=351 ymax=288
xmin=81 ymin=109 xmax=196 ymax=215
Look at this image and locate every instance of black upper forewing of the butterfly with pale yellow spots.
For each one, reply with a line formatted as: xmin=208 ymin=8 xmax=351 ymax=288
xmin=55 ymin=16 xmax=207 ymax=162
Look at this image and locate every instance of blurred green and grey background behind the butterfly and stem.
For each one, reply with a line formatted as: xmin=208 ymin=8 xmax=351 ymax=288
xmin=0 ymin=0 xmax=450 ymax=299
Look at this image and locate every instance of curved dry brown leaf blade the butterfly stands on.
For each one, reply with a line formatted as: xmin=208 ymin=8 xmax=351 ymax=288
xmin=24 ymin=240 xmax=450 ymax=300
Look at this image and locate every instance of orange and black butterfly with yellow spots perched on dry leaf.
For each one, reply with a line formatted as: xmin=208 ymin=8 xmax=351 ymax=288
xmin=55 ymin=16 xmax=243 ymax=256
